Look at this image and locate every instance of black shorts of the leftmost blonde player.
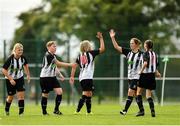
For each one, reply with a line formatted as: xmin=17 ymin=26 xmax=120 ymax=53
xmin=6 ymin=77 xmax=25 ymax=95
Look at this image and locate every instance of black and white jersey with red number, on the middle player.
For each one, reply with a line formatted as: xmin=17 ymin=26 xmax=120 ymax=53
xmin=76 ymin=50 xmax=99 ymax=81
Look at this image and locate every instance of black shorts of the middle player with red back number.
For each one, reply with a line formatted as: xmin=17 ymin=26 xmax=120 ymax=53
xmin=80 ymin=79 xmax=94 ymax=91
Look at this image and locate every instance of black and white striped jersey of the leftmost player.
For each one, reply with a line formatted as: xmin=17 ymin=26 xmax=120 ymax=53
xmin=3 ymin=54 xmax=28 ymax=79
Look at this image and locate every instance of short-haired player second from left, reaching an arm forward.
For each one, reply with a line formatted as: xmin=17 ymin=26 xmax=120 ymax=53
xmin=40 ymin=41 xmax=73 ymax=115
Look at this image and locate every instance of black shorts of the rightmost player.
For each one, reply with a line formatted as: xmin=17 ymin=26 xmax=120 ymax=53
xmin=138 ymin=73 xmax=156 ymax=90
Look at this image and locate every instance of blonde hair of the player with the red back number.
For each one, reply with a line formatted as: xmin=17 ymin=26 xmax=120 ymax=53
xmin=80 ymin=40 xmax=91 ymax=53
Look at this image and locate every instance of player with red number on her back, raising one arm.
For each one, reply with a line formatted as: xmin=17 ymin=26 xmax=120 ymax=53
xmin=70 ymin=32 xmax=105 ymax=115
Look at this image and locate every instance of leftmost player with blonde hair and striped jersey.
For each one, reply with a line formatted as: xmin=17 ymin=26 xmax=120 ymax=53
xmin=2 ymin=43 xmax=30 ymax=115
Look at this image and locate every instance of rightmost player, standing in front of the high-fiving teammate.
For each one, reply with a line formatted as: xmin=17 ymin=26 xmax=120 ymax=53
xmin=136 ymin=40 xmax=161 ymax=117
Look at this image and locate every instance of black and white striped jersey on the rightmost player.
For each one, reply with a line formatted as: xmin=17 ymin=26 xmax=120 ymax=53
xmin=143 ymin=51 xmax=158 ymax=73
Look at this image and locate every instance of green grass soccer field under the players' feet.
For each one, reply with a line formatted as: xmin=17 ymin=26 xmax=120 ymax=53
xmin=0 ymin=104 xmax=180 ymax=125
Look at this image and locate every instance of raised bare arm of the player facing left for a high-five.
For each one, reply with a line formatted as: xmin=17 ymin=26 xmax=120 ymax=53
xmin=109 ymin=29 xmax=122 ymax=53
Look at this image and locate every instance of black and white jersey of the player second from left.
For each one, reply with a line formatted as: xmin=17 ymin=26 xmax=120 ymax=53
xmin=40 ymin=52 xmax=57 ymax=77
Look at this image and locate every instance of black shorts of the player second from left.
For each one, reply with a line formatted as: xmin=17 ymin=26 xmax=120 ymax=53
xmin=40 ymin=77 xmax=61 ymax=93
